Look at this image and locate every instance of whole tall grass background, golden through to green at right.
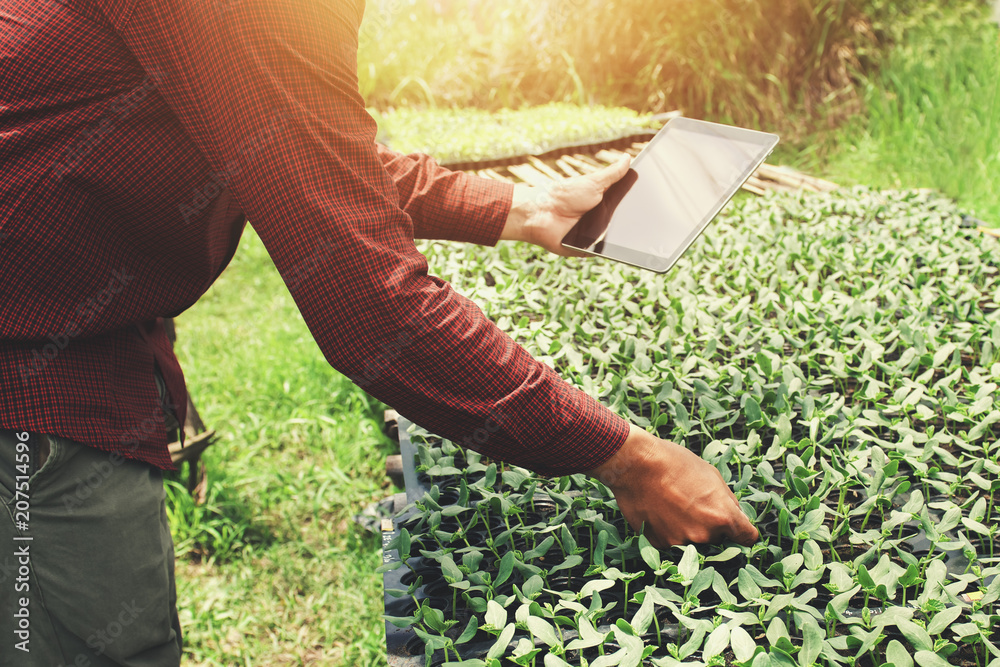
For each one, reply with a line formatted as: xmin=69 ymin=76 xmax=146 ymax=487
xmin=359 ymin=0 xmax=1000 ymax=219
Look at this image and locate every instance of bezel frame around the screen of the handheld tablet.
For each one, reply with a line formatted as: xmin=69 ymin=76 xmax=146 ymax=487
xmin=562 ymin=117 xmax=778 ymax=273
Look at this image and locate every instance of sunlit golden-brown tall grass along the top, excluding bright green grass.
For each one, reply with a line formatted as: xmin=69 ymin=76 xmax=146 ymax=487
xmin=359 ymin=0 xmax=881 ymax=133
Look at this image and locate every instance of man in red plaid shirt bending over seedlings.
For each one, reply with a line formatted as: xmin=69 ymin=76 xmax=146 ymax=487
xmin=0 ymin=0 xmax=757 ymax=667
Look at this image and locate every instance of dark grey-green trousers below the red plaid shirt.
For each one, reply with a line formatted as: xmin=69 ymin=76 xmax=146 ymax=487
xmin=0 ymin=430 xmax=181 ymax=667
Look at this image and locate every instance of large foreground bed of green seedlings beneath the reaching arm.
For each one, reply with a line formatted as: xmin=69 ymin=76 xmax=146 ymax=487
xmin=390 ymin=188 xmax=1000 ymax=667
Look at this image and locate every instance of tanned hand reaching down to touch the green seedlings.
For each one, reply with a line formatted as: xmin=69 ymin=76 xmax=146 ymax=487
xmin=589 ymin=425 xmax=760 ymax=548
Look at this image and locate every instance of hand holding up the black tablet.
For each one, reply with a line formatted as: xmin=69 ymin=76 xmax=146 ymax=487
xmin=500 ymin=155 xmax=632 ymax=257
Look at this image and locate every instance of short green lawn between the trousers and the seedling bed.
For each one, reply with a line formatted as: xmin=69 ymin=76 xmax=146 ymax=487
xmin=170 ymin=230 xmax=392 ymax=666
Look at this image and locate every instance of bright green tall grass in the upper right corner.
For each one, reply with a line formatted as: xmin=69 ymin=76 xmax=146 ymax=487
xmin=825 ymin=2 xmax=1000 ymax=225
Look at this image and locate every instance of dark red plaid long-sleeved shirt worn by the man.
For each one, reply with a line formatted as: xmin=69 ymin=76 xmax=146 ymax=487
xmin=0 ymin=0 xmax=628 ymax=473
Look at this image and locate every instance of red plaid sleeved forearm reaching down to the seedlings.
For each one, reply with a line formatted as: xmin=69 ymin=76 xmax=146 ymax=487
xmin=348 ymin=284 xmax=629 ymax=475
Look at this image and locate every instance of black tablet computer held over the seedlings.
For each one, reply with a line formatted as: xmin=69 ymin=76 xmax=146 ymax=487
xmin=562 ymin=118 xmax=778 ymax=273
